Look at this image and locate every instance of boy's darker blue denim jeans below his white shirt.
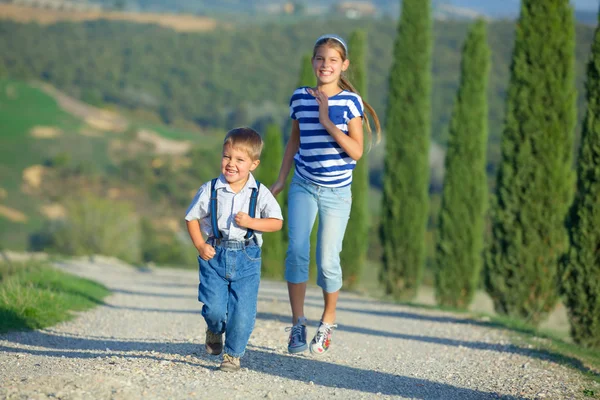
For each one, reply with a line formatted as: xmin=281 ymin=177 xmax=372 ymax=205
xmin=198 ymin=242 xmax=261 ymax=357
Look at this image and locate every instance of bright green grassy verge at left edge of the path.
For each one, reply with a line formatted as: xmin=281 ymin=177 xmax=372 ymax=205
xmin=0 ymin=262 xmax=109 ymax=333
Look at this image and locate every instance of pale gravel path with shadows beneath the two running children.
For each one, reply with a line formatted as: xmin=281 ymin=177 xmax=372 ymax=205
xmin=0 ymin=260 xmax=600 ymax=400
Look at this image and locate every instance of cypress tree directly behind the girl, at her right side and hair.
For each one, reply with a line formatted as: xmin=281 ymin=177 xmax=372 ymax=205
xmin=340 ymin=30 xmax=369 ymax=289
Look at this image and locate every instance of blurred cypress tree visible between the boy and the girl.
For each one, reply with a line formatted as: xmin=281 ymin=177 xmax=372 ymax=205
xmin=256 ymin=123 xmax=286 ymax=279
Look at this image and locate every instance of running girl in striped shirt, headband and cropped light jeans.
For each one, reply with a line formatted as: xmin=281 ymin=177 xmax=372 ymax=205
xmin=271 ymin=35 xmax=380 ymax=355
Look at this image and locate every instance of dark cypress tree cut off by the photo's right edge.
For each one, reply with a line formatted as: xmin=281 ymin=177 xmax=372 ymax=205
xmin=562 ymin=14 xmax=600 ymax=349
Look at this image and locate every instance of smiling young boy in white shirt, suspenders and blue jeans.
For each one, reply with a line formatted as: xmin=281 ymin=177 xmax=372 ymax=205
xmin=185 ymin=128 xmax=283 ymax=371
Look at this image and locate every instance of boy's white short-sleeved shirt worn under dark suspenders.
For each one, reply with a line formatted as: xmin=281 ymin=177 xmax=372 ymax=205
xmin=185 ymin=174 xmax=283 ymax=246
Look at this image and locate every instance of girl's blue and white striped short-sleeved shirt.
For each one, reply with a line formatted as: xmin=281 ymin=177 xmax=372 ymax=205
xmin=290 ymin=87 xmax=363 ymax=187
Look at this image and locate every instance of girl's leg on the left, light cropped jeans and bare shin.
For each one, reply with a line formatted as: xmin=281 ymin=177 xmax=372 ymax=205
xmin=285 ymin=176 xmax=317 ymax=325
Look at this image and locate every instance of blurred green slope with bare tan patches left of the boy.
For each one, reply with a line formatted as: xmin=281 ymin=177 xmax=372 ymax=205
xmin=0 ymin=79 xmax=220 ymax=253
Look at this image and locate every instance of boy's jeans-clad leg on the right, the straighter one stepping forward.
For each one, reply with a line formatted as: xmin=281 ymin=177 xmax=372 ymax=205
xmin=220 ymin=246 xmax=261 ymax=358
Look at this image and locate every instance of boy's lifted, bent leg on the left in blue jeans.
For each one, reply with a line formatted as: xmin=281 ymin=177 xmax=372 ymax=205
xmin=198 ymin=247 xmax=229 ymax=344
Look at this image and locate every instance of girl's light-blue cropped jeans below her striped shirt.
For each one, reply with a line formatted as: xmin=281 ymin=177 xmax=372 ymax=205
xmin=285 ymin=175 xmax=352 ymax=293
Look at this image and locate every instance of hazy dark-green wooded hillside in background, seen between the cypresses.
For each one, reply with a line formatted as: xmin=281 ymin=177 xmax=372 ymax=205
xmin=0 ymin=19 xmax=593 ymax=171
